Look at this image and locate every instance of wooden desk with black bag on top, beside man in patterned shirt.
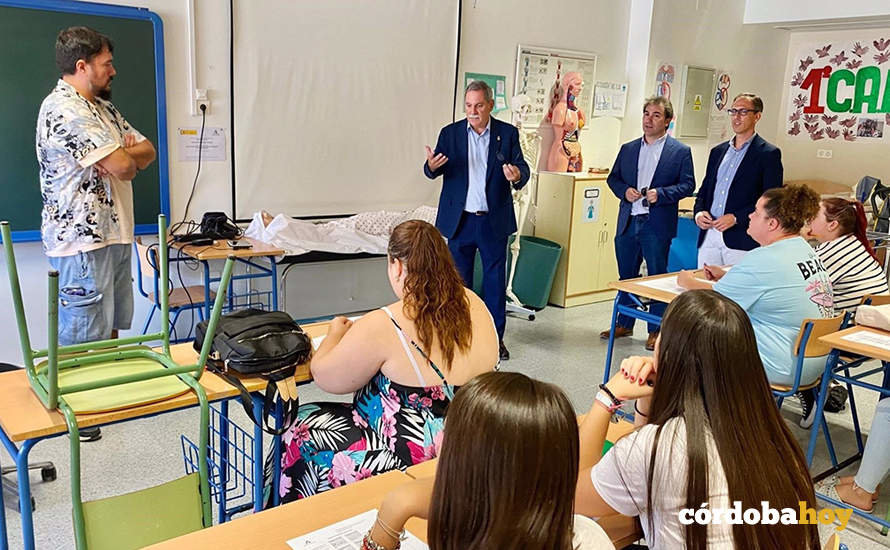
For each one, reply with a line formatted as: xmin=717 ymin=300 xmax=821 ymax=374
xmin=169 ymin=237 xmax=284 ymax=319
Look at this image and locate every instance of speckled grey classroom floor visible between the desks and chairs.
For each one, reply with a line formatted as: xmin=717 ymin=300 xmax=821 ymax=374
xmin=0 ymin=302 xmax=890 ymax=550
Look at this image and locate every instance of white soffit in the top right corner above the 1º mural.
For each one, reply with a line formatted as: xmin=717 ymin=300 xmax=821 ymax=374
xmin=745 ymin=0 xmax=890 ymax=23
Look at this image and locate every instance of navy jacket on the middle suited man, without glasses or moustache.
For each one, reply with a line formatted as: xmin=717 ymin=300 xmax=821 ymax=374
xmin=606 ymin=136 xmax=695 ymax=240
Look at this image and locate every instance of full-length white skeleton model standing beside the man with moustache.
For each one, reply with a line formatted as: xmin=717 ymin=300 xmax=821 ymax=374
xmin=507 ymin=94 xmax=541 ymax=312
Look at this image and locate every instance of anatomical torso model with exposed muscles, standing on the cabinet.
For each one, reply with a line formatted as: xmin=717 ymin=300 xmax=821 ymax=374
xmin=547 ymin=72 xmax=587 ymax=172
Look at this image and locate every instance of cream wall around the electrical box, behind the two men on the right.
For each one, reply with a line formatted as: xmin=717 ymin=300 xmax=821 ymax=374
xmin=640 ymin=0 xmax=790 ymax=184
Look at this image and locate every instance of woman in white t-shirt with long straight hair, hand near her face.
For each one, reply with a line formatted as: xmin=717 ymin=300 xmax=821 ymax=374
xmin=575 ymin=290 xmax=819 ymax=550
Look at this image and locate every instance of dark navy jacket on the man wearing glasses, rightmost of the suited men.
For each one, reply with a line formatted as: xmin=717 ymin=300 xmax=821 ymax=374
xmin=695 ymin=135 xmax=783 ymax=250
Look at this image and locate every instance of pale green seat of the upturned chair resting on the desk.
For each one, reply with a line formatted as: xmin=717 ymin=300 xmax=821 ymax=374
xmin=50 ymin=358 xmax=190 ymax=414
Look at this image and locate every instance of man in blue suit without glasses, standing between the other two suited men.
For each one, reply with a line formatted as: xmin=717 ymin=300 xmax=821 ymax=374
xmin=600 ymin=97 xmax=695 ymax=350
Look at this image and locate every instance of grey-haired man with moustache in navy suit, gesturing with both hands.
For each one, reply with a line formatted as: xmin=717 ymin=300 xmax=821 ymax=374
xmin=423 ymin=81 xmax=529 ymax=359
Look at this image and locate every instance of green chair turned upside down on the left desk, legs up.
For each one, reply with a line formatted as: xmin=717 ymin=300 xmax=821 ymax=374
xmin=0 ymin=215 xmax=234 ymax=550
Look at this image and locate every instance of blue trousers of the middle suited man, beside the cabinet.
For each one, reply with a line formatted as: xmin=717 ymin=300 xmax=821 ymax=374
xmin=615 ymin=214 xmax=671 ymax=333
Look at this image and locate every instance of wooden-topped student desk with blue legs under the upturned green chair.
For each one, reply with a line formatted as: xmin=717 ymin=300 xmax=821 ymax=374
xmin=0 ymin=322 xmax=328 ymax=549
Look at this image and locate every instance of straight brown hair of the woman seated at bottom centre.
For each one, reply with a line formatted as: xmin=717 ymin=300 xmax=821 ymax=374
xmin=427 ymin=372 xmax=579 ymax=550
